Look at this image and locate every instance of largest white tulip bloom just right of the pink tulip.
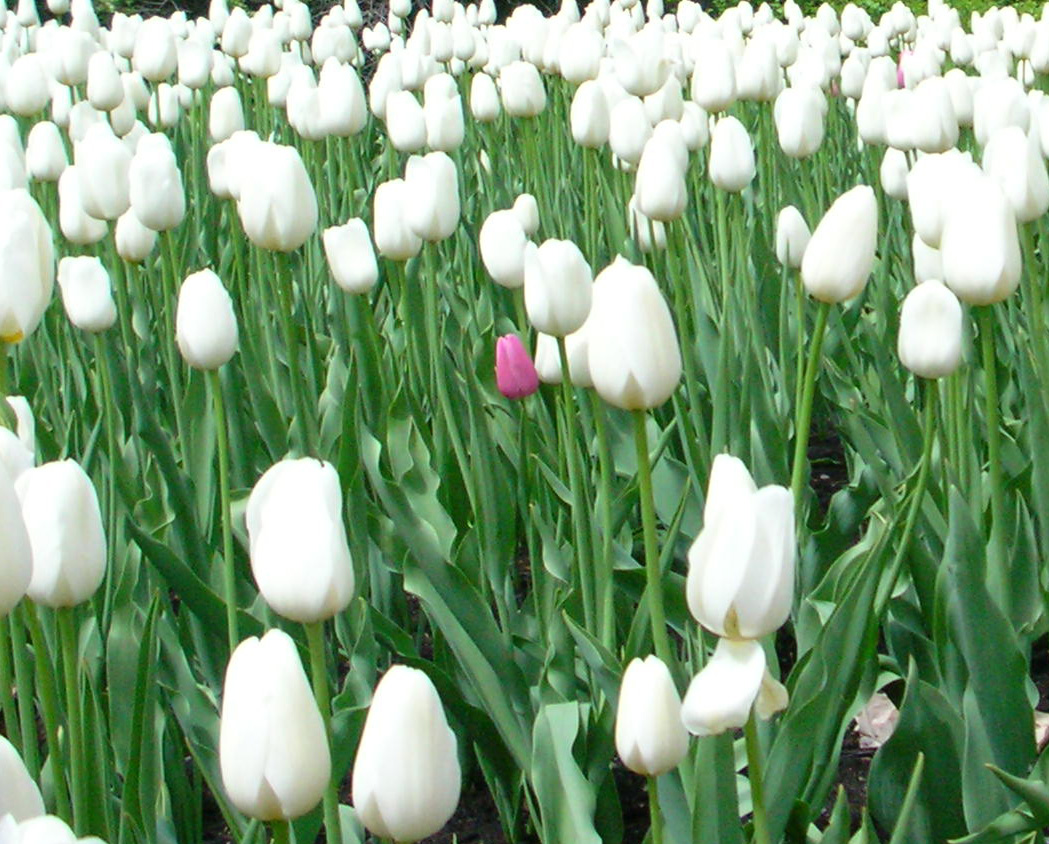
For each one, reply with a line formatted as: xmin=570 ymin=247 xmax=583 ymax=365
xmin=586 ymin=256 xmax=681 ymax=410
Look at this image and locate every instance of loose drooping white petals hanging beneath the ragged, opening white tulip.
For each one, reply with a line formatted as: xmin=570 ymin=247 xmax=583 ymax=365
xmin=681 ymin=639 xmax=788 ymax=736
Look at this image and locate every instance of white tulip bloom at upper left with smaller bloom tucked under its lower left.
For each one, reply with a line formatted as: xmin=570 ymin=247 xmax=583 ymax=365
xmin=128 ymin=134 xmax=185 ymax=232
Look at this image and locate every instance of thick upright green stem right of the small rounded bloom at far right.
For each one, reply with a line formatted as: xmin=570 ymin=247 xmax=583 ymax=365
xmin=977 ymin=305 xmax=1008 ymax=609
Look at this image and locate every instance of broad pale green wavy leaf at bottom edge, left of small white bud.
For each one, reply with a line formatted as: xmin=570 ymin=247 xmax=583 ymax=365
xmin=531 ymin=701 xmax=601 ymax=844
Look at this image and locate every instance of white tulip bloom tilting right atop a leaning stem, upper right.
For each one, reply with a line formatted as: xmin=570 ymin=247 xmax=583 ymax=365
xmin=801 ymin=185 xmax=878 ymax=303
